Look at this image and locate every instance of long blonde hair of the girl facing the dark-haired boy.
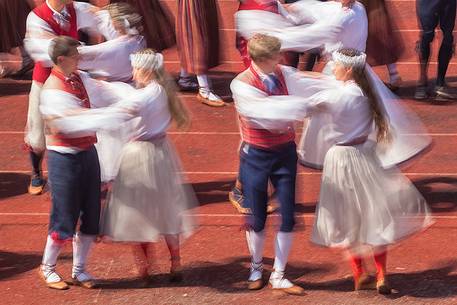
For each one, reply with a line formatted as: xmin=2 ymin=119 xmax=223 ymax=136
xmin=135 ymin=49 xmax=191 ymax=129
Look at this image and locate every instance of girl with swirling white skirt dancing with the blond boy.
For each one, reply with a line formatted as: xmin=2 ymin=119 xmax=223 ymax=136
xmin=311 ymin=49 xmax=431 ymax=294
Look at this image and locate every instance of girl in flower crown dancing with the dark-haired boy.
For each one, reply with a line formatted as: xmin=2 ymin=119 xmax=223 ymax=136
xmin=101 ymin=49 xmax=196 ymax=280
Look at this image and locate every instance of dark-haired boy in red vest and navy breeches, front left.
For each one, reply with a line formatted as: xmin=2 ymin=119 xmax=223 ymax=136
xmin=40 ymin=36 xmax=129 ymax=290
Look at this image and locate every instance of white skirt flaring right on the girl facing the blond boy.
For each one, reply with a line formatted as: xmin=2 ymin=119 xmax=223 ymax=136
xmin=311 ymin=144 xmax=432 ymax=250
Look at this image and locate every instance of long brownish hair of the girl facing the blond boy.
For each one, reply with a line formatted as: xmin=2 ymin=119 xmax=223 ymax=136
xmin=338 ymin=48 xmax=390 ymax=142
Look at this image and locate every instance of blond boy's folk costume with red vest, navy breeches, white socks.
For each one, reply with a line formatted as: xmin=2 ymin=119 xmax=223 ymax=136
xmin=230 ymin=63 xmax=318 ymax=294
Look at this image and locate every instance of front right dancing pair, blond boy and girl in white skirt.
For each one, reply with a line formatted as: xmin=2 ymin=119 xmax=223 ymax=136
xmin=231 ymin=34 xmax=431 ymax=294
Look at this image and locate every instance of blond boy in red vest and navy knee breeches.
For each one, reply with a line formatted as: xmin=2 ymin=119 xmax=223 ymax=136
xmin=231 ymin=34 xmax=304 ymax=295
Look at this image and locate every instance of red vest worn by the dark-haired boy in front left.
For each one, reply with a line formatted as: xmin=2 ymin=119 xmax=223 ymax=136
xmin=47 ymin=70 xmax=97 ymax=150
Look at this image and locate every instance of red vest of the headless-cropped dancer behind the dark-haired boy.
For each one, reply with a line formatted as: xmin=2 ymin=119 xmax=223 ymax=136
xmin=33 ymin=2 xmax=78 ymax=83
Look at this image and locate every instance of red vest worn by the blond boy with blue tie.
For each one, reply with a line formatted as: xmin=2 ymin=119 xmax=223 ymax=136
xmin=240 ymin=66 xmax=295 ymax=150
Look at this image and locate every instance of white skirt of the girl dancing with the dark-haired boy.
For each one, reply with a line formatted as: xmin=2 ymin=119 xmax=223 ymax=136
xmin=100 ymin=137 xmax=197 ymax=242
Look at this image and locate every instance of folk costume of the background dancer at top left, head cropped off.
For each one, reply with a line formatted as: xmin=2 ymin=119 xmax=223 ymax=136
xmin=24 ymin=1 xmax=117 ymax=195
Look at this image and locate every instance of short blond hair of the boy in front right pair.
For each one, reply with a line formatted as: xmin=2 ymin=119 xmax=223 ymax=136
xmin=248 ymin=34 xmax=281 ymax=62
